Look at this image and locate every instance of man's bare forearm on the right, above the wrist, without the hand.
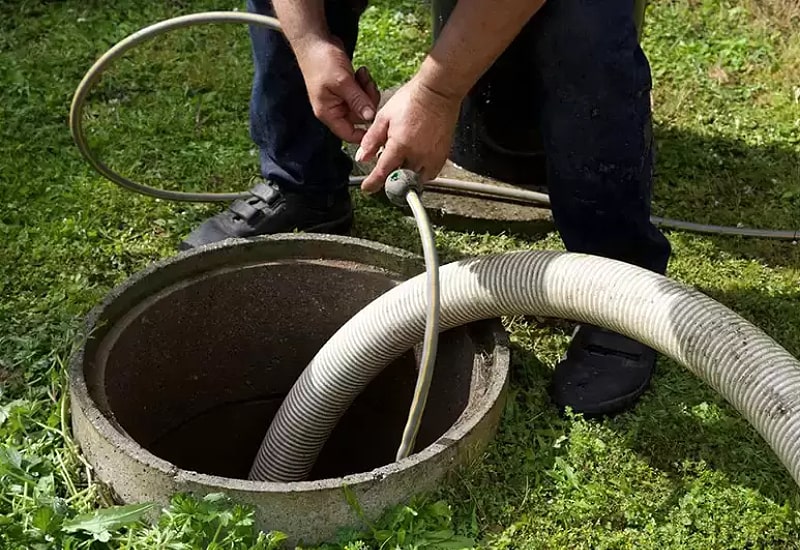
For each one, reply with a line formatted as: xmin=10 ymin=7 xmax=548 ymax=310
xmin=417 ymin=0 xmax=545 ymax=99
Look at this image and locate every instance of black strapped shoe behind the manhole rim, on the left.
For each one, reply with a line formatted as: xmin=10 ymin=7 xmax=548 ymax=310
xmin=179 ymin=182 xmax=353 ymax=250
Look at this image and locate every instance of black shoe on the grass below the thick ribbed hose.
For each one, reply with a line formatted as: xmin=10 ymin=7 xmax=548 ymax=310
xmin=550 ymin=325 xmax=656 ymax=417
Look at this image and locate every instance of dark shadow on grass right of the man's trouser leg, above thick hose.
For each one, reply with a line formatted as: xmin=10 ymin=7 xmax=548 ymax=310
xmin=653 ymin=127 xmax=800 ymax=267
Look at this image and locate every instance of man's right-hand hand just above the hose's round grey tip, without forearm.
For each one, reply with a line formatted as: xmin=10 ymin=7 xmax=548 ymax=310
xmin=356 ymin=77 xmax=461 ymax=193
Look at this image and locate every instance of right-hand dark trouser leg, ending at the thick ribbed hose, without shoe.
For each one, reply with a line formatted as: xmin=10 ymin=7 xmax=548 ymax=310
xmin=526 ymin=0 xmax=670 ymax=273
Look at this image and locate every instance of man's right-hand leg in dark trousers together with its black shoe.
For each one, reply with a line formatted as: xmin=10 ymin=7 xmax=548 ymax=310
xmin=500 ymin=0 xmax=670 ymax=414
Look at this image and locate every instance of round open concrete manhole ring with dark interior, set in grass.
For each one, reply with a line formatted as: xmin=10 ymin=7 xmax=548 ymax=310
xmin=70 ymin=234 xmax=509 ymax=544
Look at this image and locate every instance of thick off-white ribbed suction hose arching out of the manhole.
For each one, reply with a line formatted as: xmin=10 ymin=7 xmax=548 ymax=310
xmin=250 ymin=251 xmax=800 ymax=484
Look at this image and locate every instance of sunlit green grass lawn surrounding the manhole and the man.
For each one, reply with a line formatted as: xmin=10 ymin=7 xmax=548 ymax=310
xmin=0 ymin=0 xmax=800 ymax=549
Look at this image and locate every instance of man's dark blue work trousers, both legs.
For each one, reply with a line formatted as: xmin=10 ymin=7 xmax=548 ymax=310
xmin=247 ymin=0 xmax=670 ymax=273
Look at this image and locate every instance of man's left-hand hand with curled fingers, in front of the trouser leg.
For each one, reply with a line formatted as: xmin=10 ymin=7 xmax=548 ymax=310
xmin=295 ymin=38 xmax=380 ymax=143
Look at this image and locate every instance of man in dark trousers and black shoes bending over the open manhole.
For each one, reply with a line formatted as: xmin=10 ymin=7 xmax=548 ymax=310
xmin=184 ymin=0 xmax=670 ymax=415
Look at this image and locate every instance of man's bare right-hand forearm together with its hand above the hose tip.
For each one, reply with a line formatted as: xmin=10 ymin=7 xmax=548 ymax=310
xmin=356 ymin=0 xmax=545 ymax=192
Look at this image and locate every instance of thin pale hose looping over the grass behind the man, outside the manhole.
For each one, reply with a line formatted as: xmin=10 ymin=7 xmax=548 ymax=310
xmin=69 ymin=11 xmax=800 ymax=241
